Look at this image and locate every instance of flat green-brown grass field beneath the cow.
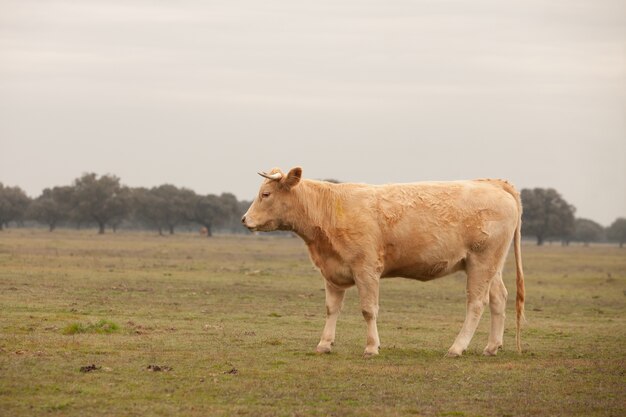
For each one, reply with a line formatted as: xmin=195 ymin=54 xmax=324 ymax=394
xmin=0 ymin=229 xmax=626 ymax=417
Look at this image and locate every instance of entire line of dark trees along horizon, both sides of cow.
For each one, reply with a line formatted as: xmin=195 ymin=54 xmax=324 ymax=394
xmin=0 ymin=173 xmax=626 ymax=247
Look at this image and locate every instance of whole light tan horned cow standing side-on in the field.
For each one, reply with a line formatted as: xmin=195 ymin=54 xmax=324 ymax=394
xmin=241 ymin=167 xmax=525 ymax=357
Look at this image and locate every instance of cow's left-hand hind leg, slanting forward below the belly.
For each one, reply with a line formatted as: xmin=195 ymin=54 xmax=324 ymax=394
xmin=447 ymin=257 xmax=497 ymax=357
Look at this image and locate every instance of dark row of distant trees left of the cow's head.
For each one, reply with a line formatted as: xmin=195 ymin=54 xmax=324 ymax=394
xmin=0 ymin=173 xmax=250 ymax=237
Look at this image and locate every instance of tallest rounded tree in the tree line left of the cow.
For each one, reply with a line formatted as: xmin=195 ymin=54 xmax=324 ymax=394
xmin=73 ymin=173 xmax=130 ymax=234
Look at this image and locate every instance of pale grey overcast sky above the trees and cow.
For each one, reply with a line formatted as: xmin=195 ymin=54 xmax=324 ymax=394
xmin=0 ymin=0 xmax=626 ymax=225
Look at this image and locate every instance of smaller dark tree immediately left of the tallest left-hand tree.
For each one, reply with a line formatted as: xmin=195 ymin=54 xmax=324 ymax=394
xmin=27 ymin=186 xmax=73 ymax=232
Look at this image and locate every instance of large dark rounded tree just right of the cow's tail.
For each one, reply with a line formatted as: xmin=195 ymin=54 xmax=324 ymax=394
xmin=521 ymin=188 xmax=576 ymax=245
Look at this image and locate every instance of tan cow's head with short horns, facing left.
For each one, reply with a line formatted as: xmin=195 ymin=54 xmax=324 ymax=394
xmin=241 ymin=167 xmax=302 ymax=232
